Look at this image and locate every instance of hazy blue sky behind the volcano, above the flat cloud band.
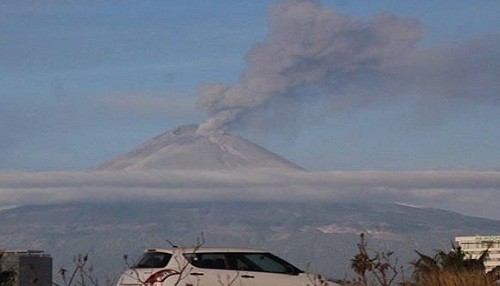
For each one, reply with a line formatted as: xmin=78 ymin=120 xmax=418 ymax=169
xmin=0 ymin=0 xmax=500 ymax=171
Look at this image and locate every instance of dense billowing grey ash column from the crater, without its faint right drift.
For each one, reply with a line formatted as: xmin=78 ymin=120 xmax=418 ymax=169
xmin=198 ymin=1 xmax=422 ymax=132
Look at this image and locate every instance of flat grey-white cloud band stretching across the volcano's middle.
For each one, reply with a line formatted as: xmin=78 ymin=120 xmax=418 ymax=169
xmin=0 ymin=170 xmax=500 ymax=219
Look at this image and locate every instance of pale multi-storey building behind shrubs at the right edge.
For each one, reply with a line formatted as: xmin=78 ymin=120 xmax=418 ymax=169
xmin=455 ymin=235 xmax=500 ymax=271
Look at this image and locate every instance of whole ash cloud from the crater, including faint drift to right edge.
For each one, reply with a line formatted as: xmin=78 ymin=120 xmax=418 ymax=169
xmin=198 ymin=1 xmax=500 ymax=133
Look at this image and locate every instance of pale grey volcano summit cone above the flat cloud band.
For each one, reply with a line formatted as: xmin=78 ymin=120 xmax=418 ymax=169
xmin=97 ymin=125 xmax=304 ymax=170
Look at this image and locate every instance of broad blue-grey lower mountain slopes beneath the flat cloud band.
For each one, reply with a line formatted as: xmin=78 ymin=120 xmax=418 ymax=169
xmin=0 ymin=201 xmax=500 ymax=278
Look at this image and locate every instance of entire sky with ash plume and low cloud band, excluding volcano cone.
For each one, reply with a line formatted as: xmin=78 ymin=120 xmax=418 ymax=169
xmin=0 ymin=0 xmax=500 ymax=219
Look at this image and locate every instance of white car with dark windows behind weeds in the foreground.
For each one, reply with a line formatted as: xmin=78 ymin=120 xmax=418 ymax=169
xmin=118 ymin=247 xmax=338 ymax=286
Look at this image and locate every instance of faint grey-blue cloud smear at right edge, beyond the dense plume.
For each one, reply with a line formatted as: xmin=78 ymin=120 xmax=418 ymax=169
xmin=384 ymin=35 xmax=500 ymax=104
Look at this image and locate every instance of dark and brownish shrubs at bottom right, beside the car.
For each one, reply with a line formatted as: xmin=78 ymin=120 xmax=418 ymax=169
xmin=341 ymin=234 xmax=500 ymax=286
